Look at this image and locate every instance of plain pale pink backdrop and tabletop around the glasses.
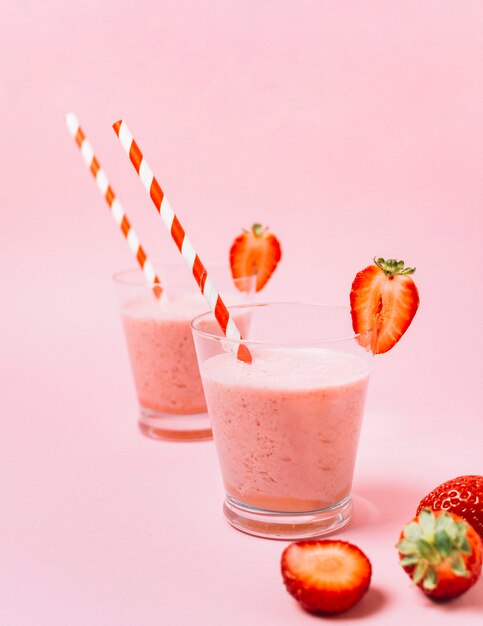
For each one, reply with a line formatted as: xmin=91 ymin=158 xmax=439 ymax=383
xmin=0 ymin=0 xmax=483 ymax=626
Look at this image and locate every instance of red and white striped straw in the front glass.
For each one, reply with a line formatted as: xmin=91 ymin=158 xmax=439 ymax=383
xmin=113 ymin=120 xmax=252 ymax=363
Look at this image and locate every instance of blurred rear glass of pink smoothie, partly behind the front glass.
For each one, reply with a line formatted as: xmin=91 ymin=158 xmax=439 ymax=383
xmin=114 ymin=266 xmax=256 ymax=441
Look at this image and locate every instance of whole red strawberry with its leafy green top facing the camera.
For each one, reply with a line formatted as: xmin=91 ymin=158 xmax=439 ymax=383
xmin=396 ymin=509 xmax=483 ymax=600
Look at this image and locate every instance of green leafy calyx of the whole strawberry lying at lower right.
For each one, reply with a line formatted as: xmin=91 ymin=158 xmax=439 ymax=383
xmin=396 ymin=509 xmax=471 ymax=591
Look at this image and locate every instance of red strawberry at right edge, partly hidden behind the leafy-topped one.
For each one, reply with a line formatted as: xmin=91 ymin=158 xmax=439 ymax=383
xmin=417 ymin=476 xmax=483 ymax=541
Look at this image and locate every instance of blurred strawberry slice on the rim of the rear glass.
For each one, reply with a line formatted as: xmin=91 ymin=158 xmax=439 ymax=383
xmin=230 ymin=224 xmax=282 ymax=291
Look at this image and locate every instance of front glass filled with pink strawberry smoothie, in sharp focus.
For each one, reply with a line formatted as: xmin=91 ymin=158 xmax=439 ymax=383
xmin=192 ymin=302 xmax=372 ymax=539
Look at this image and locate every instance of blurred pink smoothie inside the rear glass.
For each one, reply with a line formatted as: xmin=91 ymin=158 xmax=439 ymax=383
xmin=122 ymin=293 xmax=207 ymax=414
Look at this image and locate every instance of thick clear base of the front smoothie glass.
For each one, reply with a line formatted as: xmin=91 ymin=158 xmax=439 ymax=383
xmin=223 ymin=496 xmax=354 ymax=540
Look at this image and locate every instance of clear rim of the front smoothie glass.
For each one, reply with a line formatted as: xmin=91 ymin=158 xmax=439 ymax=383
xmin=190 ymin=300 xmax=373 ymax=352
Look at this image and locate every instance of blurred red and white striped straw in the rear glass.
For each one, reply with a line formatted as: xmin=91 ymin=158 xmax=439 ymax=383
xmin=65 ymin=113 xmax=162 ymax=298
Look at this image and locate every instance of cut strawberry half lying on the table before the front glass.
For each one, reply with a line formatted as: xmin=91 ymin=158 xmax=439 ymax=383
xmin=282 ymin=540 xmax=372 ymax=614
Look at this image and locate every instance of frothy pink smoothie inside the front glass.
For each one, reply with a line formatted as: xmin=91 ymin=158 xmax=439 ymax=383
xmin=201 ymin=349 xmax=369 ymax=512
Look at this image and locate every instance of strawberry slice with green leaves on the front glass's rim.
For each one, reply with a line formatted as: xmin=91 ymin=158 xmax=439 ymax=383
xmin=350 ymin=258 xmax=419 ymax=354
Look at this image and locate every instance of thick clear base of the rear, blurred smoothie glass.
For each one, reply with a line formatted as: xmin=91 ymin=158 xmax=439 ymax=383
xmin=138 ymin=407 xmax=213 ymax=441
